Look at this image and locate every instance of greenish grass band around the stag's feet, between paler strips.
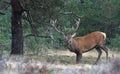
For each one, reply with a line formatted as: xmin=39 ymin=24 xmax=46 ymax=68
xmin=25 ymin=52 xmax=106 ymax=64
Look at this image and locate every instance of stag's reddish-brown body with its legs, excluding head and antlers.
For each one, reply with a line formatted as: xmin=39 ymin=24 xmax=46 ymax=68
xmin=68 ymin=31 xmax=108 ymax=64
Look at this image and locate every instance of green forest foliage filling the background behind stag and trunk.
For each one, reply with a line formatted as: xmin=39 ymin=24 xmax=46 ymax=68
xmin=0 ymin=0 xmax=120 ymax=51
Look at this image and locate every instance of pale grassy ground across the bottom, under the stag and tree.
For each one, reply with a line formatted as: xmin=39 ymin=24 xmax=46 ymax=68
xmin=0 ymin=50 xmax=119 ymax=74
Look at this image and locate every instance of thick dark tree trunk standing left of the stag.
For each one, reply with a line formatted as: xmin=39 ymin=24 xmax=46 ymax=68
xmin=11 ymin=0 xmax=24 ymax=55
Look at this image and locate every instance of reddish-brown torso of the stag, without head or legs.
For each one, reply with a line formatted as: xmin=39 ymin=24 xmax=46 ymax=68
xmin=68 ymin=31 xmax=106 ymax=53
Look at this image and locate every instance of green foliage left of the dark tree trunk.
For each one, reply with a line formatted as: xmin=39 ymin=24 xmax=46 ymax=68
xmin=0 ymin=8 xmax=11 ymax=50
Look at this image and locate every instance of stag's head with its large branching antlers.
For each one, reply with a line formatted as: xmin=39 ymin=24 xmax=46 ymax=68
xmin=50 ymin=19 xmax=80 ymax=44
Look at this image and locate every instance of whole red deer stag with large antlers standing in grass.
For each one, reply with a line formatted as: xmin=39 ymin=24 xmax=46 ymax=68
xmin=50 ymin=19 xmax=108 ymax=64
